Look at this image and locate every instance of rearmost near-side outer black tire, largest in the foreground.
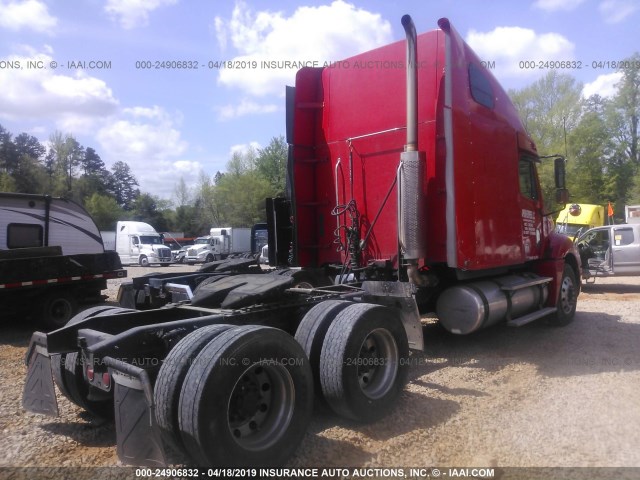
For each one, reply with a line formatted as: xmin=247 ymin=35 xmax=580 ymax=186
xmin=179 ymin=326 xmax=313 ymax=467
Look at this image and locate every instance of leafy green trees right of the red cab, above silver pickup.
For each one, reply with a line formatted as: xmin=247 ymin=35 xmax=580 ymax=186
xmin=509 ymin=53 xmax=640 ymax=218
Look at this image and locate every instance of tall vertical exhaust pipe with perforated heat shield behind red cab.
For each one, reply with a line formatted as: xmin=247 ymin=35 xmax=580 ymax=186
xmin=397 ymin=15 xmax=427 ymax=286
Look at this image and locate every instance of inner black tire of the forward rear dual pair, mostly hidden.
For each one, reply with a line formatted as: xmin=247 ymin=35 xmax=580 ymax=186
xmin=295 ymin=300 xmax=353 ymax=403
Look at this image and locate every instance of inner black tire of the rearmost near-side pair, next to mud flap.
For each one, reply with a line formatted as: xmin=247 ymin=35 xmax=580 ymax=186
xmin=154 ymin=325 xmax=233 ymax=454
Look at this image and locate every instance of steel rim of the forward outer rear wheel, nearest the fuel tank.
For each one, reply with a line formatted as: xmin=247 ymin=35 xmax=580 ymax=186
xmin=357 ymin=328 xmax=399 ymax=400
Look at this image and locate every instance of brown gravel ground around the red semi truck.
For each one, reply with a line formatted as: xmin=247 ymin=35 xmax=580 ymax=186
xmin=0 ymin=266 xmax=640 ymax=478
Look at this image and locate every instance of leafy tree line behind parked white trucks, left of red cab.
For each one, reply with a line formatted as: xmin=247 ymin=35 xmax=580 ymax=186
xmin=0 ymin=129 xmax=287 ymax=236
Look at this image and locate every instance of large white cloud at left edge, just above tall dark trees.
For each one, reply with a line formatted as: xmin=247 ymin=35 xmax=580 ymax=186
xmin=0 ymin=46 xmax=118 ymax=126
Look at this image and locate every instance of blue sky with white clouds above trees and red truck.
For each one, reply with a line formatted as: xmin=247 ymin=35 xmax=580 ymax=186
xmin=0 ymin=0 xmax=640 ymax=199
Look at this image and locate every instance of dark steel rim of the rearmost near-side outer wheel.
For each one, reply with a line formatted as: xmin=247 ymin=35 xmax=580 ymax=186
xmin=227 ymin=360 xmax=295 ymax=451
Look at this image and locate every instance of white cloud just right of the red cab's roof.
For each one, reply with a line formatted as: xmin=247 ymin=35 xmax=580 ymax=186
xmin=466 ymin=27 xmax=575 ymax=77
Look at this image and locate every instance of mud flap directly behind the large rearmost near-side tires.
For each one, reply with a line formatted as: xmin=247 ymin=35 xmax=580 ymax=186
xmin=104 ymin=357 xmax=166 ymax=467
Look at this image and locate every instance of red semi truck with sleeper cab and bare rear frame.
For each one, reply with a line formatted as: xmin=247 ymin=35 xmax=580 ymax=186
xmin=23 ymin=16 xmax=580 ymax=466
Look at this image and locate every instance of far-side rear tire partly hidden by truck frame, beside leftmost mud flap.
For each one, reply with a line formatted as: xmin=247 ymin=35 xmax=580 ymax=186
xmin=60 ymin=305 xmax=134 ymax=418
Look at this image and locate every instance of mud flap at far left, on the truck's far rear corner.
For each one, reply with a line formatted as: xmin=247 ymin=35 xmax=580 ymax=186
xmin=22 ymin=332 xmax=58 ymax=417
